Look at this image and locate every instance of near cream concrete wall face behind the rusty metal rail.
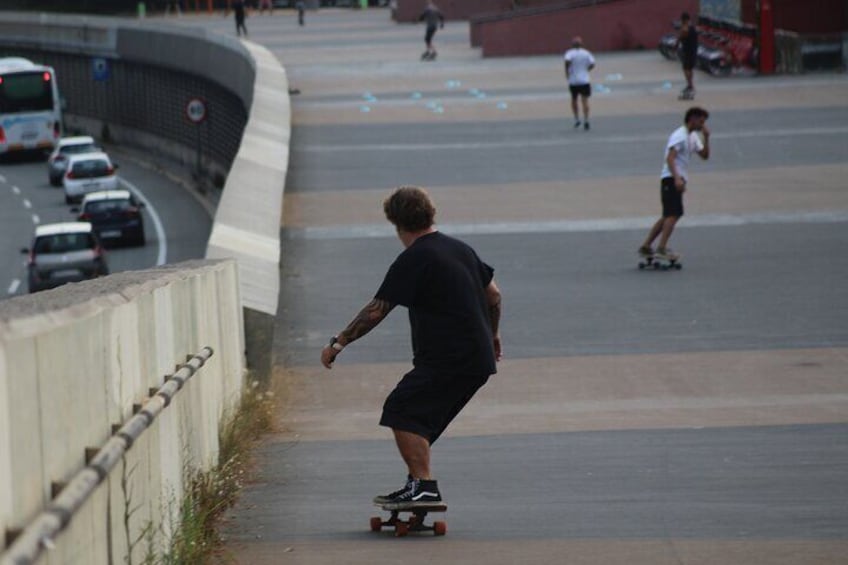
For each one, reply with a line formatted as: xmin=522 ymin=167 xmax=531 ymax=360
xmin=0 ymin=259 xmax=244 ymax=565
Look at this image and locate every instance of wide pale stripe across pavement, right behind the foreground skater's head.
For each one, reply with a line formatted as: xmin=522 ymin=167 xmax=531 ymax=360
xmin=286 ymin=211 xmax=848 ymax=240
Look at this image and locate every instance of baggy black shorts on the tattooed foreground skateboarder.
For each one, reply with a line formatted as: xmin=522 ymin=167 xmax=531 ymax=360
xmin=380 ymin=369 xmax=489 ymax=445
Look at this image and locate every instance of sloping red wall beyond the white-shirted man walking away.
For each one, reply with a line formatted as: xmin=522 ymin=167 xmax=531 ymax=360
xmin=471 ymin=0 xmax=699 ymax=57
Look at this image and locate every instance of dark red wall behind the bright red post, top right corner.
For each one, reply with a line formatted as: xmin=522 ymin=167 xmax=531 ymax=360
xmin=742 ymin=0 xmax=848 ymax=33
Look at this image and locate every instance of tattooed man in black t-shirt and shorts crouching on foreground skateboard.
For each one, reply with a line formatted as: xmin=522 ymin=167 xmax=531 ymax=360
xmin=321 ymin=186 xmax=501 ymax=510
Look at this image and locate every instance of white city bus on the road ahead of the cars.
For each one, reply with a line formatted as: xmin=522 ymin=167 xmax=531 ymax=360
xmin=0 ymin=57 xmax=62 ymax=155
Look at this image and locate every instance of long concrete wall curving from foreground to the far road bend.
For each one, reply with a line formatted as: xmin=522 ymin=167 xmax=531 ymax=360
xmin=0 ymin=13 xmax=290 ymax=565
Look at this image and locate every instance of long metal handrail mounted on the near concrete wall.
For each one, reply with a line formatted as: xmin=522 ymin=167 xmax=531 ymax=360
xmin=0 ymin=346 xmax=214 ymax=565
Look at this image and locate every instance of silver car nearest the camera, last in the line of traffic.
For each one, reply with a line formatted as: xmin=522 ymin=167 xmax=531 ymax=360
xmin=21 ymin=222 xmax=109 ymax=292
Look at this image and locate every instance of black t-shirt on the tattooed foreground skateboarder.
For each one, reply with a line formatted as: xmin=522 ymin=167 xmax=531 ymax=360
xmin=375 ymin=232 xmax=497 ymax=376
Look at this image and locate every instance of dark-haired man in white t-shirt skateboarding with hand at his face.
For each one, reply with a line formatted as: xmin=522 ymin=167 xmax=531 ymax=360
xmin=639 ymin=106 xmax=710 ymax=261
